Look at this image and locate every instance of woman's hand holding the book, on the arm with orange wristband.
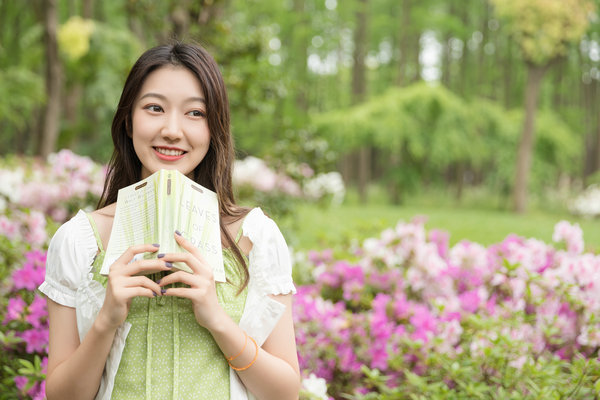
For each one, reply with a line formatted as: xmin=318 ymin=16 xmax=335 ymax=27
xmin=159 ymin=233 xmax=227 ymax=331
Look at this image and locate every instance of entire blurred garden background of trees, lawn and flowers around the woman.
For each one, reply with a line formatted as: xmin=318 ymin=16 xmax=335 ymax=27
xmin=0 ymin=0 xmax=600 ymax=400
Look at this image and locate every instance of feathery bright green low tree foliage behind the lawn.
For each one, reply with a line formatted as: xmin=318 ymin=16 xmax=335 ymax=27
xmin=313 ymin=84 xmax=581 ymax=198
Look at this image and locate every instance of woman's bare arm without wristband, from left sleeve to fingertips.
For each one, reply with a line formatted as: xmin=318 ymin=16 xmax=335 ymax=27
xmin=46 ymin=245 xmax=168 ymax=400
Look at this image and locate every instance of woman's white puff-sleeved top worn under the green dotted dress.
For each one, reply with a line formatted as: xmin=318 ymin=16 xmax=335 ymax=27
xmin=39 ymin=208 xmax=296 ymax=400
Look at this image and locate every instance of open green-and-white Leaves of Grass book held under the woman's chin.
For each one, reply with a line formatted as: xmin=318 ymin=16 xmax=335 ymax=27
xmin=100 ymin=169 xmax=225 ymax=282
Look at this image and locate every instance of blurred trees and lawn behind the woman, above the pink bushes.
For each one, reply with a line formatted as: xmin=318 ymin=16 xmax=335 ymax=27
xmin=0 ymin=0 xmax=600 ymax=248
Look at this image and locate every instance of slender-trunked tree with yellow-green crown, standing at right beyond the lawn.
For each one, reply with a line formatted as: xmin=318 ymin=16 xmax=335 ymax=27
xmin=491 ymin=0 xmax=594 ymax=213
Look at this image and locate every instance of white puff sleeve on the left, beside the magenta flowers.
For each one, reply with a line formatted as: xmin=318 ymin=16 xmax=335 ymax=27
xmin=39 ymin=211 xmax=98 ymax=307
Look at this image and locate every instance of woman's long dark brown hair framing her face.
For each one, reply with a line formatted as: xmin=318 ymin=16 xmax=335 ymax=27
xmin=97 ymin=43 xmax=249 ymax=291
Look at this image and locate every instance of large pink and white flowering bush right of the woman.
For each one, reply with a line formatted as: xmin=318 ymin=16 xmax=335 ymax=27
xmin=294 ymin=219 xmax=600 ymax=399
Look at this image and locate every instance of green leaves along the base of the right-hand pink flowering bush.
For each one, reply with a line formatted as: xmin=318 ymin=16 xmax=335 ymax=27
xmin=349 ymin=315 xmax=600 ymax=400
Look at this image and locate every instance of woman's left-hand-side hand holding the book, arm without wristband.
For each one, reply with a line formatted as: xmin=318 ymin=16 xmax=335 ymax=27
xmin=97 ymin=244 xmax=170 ymax=329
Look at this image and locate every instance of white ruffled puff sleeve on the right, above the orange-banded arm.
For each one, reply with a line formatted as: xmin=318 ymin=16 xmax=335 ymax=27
xmin=242 ymin=208 xmax=296 ymax=295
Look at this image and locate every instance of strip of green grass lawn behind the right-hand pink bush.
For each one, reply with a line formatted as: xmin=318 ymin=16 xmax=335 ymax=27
xmin=282 ymin=188 xmax=600 ymax=253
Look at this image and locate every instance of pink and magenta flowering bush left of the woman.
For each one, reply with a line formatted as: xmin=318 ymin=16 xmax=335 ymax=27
xmin=0 ymin=150 xmax=104 ymax=399
